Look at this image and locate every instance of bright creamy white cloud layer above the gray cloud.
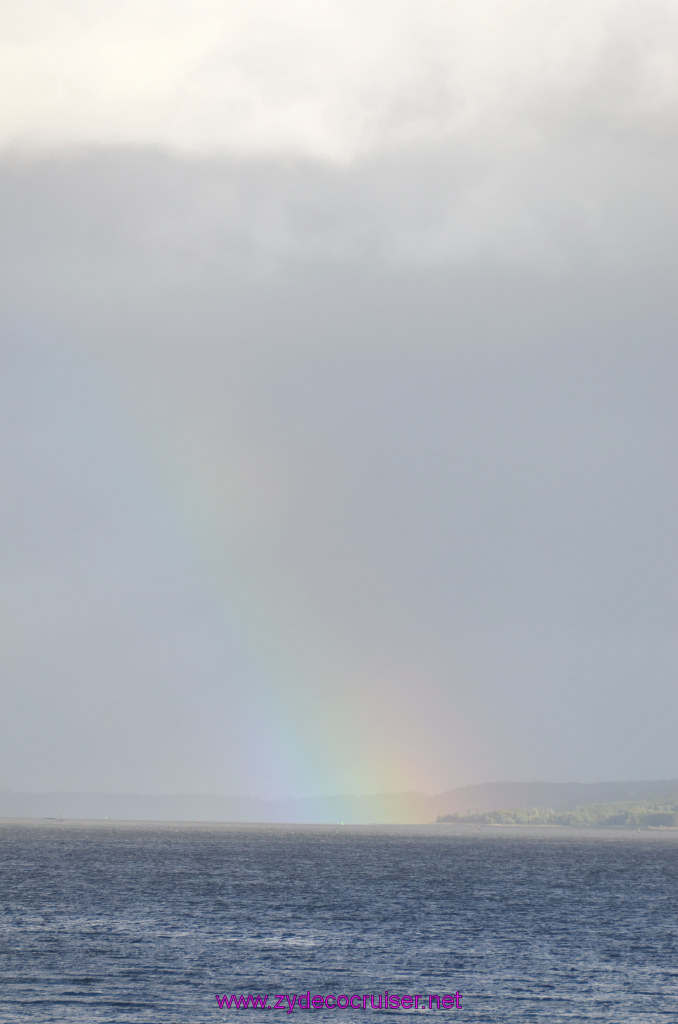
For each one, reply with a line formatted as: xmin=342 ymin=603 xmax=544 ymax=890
xmin=0 ymin=0 xmax=678 ymax=162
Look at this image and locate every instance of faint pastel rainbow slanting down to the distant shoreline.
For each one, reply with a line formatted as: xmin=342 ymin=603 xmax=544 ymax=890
xmin=39 ymin=331 xmax=475 ymax=813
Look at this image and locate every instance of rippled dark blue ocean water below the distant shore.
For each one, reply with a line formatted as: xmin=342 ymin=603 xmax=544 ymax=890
xmin=0 ymin=821 xmax=678 ymax=1024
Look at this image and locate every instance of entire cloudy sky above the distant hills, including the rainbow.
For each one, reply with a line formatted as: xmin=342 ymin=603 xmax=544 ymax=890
xmin=0 ymin=0 xmax=678 ymax=797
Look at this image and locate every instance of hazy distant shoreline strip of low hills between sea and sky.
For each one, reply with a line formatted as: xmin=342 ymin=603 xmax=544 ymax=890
xmin=0 ymin=779 xmax=678 ymax=827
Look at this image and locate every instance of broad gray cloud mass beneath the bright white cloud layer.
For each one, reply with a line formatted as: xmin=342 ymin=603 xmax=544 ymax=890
xmin=0 ymin=132 xmax=678 ymax=793
